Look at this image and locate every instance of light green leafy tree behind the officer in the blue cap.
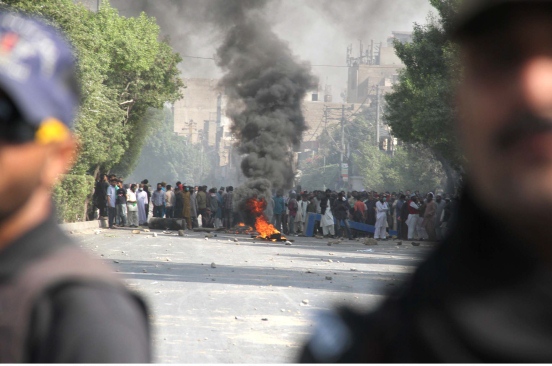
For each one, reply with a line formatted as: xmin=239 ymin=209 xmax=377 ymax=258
xmin=0 ymin=0 xmax=183 ymax=176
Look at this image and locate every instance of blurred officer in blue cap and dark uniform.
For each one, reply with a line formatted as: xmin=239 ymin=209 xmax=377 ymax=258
xmin=0 ymin=11 xmax=151 ymax=363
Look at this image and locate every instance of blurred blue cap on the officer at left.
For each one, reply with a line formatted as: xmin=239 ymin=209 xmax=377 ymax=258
xmin=0 ymin=12 xmax=80 ymax=127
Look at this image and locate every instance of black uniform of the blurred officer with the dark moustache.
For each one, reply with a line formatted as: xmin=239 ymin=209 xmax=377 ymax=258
xmin=300 ymin=192 xmax=552 ymax=363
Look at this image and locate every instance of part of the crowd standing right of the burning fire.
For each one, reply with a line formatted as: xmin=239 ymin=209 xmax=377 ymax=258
xmin=267 ymin=189 xmax=456 ymax=241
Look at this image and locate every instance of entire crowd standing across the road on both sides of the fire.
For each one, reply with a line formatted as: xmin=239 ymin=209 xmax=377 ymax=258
xmin=94 ymin=174 xmax=456 ymax=241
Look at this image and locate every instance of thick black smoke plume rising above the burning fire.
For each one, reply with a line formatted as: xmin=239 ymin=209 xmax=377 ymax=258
xmin=217 ymin=4 xmax=317 ymax=192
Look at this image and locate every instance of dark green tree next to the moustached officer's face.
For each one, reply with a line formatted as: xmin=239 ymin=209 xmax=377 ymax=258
xmin=384 ymin=0 xmax=464 ymax=191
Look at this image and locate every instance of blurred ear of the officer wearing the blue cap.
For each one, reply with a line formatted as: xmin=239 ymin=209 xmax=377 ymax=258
xmin=42 ymin=134 xmax=77 ymax=188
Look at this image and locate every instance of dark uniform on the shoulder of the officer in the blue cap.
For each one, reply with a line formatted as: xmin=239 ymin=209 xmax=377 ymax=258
xmin=0 ymin=215 xmax=151 ymax=363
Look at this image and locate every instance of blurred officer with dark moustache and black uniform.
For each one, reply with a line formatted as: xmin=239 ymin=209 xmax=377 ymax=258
xmin=301 ymin=0 xmax=552 ymax=363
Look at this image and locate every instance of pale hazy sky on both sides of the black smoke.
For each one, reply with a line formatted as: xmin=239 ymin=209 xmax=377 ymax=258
xmin=111 ymin=0 xmax=433 ymax=101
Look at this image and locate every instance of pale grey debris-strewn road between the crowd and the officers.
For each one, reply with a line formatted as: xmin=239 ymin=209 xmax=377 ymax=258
xmin=73 ymin=229 xmax=432 ymax=363
